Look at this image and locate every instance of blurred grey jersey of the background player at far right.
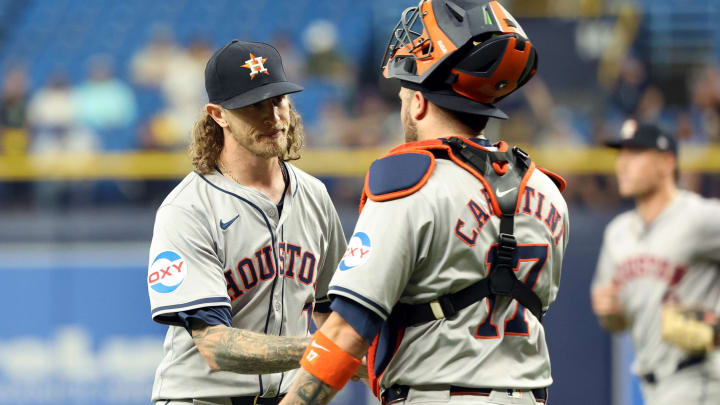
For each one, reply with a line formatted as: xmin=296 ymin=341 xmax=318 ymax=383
xmin=593 ymin=191 xmax=720 ymax=377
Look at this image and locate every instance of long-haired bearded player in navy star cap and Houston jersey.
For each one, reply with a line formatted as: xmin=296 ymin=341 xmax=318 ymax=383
xmin=148 ymin=41 xmax=345 ymax=405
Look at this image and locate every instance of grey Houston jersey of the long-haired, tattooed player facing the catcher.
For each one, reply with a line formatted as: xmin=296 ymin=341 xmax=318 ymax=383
xmin=147 ymin=164 xmax=346 ymax=400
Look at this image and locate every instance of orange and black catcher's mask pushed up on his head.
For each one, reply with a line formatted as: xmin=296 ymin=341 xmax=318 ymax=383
xmin=382 ymin=0 xmax=537 ymax=119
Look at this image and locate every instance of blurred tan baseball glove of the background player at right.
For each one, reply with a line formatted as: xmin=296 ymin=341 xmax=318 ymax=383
xmin=661 ymin=306 xmax=720 ymax=353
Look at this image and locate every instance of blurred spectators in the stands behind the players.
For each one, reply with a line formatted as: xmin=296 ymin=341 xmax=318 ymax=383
xmin=0 ymin=11 xmax=720 ymax=211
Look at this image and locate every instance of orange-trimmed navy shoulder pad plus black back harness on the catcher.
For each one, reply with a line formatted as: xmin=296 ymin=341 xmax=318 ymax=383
xmin=360 ymin=137 xmax=565 ymax=325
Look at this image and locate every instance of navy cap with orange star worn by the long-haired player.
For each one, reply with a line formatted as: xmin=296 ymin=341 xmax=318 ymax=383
xmin=205 ymin=39 xmax=303 ymax=110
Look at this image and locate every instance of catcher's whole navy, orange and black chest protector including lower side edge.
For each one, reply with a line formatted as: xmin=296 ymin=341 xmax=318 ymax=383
xmin=361 ymin=138 xmax=564 ymax=395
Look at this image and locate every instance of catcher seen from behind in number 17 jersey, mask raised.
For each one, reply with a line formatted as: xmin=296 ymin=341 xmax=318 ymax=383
xmin=282 ymin=0 xmax=568 ymax=404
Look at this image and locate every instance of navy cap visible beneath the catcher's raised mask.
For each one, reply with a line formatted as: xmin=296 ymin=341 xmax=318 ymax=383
xmin=400 ymin=80 xmax=508 ymax=120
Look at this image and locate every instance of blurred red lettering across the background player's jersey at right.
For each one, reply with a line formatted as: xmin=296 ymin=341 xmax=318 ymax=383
xmin=612 ymin=255 xmax=686 ymax=287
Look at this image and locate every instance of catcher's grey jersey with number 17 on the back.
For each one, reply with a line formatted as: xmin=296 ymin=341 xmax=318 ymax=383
xmin=330 ymin=155 xmax=568 ymax=389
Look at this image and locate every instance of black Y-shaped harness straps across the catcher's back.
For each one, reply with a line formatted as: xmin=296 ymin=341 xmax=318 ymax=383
xmin=390 ymin=137 xmax=543 ymax=326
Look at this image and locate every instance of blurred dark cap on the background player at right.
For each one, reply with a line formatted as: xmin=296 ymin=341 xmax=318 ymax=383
xmin=605 ymin=119 xmax=678 ymax=156
